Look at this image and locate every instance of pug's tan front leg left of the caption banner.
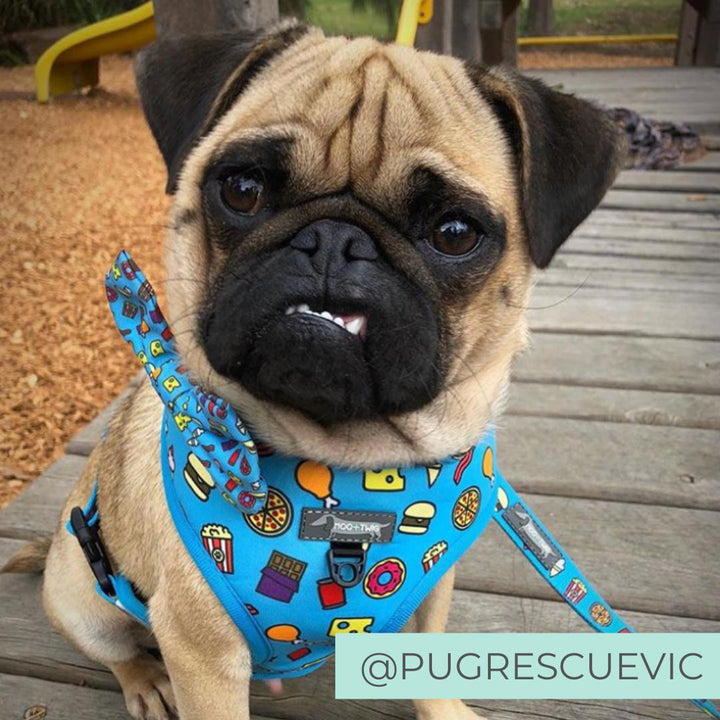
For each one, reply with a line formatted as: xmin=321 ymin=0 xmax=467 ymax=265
xmin=150 ymin=578 xmax=251 ymax=720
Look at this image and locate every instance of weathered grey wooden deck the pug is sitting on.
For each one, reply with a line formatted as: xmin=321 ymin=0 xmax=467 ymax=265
xmin=0 ymin=70 xmax=720 ymax=720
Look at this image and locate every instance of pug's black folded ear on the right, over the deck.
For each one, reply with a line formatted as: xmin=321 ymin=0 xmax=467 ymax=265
xmin=468 ymin=66 xmax=624 ymax=268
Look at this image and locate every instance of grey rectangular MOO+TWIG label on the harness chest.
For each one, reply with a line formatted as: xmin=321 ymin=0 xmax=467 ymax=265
xmin=300 ymin=508 xmax=397 ymax=543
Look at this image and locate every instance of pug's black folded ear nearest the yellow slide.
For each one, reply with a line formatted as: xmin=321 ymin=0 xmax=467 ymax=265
xmin=135 ymin=22 xmax=307 ymax=193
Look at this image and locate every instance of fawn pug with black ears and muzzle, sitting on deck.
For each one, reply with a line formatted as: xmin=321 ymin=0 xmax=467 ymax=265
xmin=16 ymin=19 xmax=622 ymax=720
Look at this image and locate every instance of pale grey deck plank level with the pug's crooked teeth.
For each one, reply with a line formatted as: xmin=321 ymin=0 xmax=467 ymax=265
xmin=528 ymin=286 xmax=720 ymax=340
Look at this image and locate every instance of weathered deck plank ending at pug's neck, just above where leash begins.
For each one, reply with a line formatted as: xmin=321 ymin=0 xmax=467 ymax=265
xmin=498 ymin=416 xmax=720 ymax=510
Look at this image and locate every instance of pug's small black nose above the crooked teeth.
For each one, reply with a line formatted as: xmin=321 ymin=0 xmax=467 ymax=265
xmin=290 ymin=220 xmax=380 ymax=272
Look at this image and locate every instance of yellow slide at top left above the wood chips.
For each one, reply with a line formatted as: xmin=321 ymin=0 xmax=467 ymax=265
xmin=35 ymin=2 xmax=156 ymax=102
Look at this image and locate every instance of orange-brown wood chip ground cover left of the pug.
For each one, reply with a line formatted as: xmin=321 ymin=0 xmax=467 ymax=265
xmin=0 ymin=57 xmax=168 ymax=507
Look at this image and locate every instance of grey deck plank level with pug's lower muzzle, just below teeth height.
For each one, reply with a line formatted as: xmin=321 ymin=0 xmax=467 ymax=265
xmin=513 ymin=333 xmax=720 ymax=395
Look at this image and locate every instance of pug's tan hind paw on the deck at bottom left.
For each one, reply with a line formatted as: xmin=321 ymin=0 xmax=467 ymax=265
xmin=112 ymin=655 xmax=177 ymax=720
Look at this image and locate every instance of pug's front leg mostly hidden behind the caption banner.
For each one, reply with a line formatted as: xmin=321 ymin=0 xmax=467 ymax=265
xmin=405 ymin=567 xmax=484 ymax=720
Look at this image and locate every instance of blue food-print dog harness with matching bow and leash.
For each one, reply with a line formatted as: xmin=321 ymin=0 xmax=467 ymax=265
xmin=68 ymin=252 xmax=720 ymax=718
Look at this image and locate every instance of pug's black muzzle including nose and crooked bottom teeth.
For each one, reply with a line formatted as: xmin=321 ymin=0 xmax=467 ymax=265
xmin=201 ymin=220 xmax=443 ymax=425
